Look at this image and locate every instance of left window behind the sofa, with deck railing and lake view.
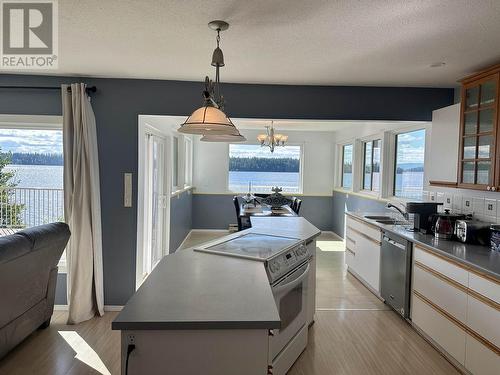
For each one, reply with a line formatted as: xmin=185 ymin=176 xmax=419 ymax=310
xmin=0 ymin=124 xmax=66 ymax=272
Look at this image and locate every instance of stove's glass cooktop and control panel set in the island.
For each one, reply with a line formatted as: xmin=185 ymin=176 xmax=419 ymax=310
xmin=195 ymin=233 xmax=311 ymax=284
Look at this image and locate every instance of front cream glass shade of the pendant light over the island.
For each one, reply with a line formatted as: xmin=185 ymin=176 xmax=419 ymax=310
xmin=178 ymin=105 xmax=240 ymax=135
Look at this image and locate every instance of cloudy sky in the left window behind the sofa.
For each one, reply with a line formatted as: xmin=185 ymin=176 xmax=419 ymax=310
xmin=0 ymin=129 xmax=63 ymax=154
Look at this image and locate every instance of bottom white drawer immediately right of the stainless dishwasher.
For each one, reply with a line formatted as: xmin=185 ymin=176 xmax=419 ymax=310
xmin=412 ymin=292 xmax=466 ymax=365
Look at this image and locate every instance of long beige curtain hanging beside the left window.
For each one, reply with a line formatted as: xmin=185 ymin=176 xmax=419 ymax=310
xmin=61 ymin=83 xmax=104 ymax=324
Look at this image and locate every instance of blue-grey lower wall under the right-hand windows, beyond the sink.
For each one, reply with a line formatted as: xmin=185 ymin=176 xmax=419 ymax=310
xmin=331 ymin=191 xmax=388 ymax=237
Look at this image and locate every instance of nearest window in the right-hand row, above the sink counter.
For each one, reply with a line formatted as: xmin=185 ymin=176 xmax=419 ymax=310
xmin=394 ymin=129 xmax=425 ymax=199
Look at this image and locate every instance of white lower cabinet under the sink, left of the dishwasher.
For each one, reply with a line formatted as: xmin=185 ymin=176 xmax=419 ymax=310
xmin=345 ymin=216 xmax=381 ymax=294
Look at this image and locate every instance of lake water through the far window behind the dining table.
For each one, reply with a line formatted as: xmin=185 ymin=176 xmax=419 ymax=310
xmin=229 ymin=171 xmax=300 ymax=194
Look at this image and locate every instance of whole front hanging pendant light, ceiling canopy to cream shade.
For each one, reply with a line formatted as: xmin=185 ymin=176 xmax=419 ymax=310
xmin=178 ymin=21 xmax=241 ymax=137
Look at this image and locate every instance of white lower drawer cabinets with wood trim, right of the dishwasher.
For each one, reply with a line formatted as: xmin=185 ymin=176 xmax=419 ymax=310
xmin=412 ymin=246 xmax=500 ymax=375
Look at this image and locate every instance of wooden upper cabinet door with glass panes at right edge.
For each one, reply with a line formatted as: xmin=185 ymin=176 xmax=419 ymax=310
xmin=458 ymin=65 xmax=500 ymax=191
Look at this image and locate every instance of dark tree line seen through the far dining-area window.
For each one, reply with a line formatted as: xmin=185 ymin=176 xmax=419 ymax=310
xmin=229 ymin=157 xmax=300 ymax=172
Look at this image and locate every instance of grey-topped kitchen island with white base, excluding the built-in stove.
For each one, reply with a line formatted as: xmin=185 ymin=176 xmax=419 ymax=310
xmin=112 ymin=217 xmax=320 ymax=375
